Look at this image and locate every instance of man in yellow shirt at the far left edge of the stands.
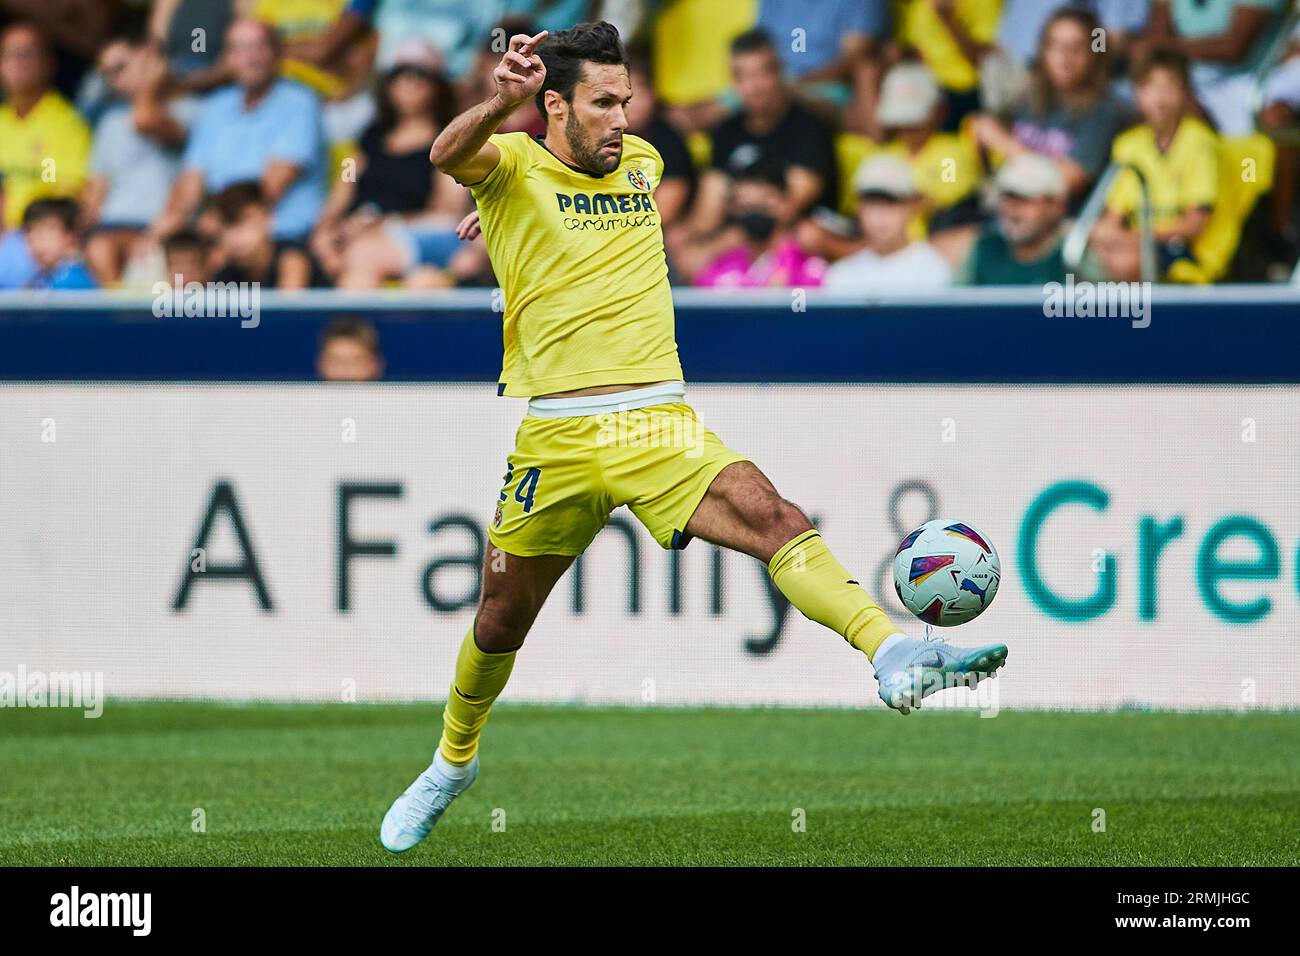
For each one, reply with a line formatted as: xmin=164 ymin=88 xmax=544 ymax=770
xmin=0 ymin=22 xmax=90 ymax=229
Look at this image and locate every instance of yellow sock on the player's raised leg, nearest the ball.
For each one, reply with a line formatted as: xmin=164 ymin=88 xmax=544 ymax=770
xmin=767 ymin=531 xmax=898 ymax=661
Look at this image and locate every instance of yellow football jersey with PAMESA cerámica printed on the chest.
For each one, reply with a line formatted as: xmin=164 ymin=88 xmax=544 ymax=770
xmin=471 ymin=133 xmax=683 ymax=397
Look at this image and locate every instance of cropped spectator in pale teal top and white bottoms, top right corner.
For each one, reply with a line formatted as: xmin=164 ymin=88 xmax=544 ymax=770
xmin=1135 ymin=0 xmax=1283 ymax=137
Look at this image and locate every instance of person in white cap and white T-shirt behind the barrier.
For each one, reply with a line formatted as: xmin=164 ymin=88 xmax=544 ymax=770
xmin=823 ymin=153 xmax=952 ymax=294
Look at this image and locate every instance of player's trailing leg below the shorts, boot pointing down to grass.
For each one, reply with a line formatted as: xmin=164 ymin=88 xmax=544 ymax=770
xmin=380 ymin=550 xmax=573 ymax=853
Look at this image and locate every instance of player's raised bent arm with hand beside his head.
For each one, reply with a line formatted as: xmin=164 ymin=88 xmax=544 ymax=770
xmin=429 ymin=30 xmax=546 ymax=186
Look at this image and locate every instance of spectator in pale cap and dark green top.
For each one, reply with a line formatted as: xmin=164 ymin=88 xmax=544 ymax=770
xmin=931 ymin=152 xmax=1066 ymax=285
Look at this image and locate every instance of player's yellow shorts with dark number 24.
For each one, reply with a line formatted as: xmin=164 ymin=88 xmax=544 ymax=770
xmin=488 ymin=402 xmax=745 ymax=557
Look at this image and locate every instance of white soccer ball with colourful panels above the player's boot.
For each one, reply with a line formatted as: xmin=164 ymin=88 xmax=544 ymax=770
xmin=894 ymin=519 xmax=1002 ymax=627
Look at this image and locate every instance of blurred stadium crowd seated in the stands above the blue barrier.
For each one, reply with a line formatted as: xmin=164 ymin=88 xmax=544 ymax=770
xmin=0 ymin=0 xmax=1300 ymax=293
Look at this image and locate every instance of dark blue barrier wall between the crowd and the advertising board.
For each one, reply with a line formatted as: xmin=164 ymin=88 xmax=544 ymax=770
xmin=0 ymin=286 xmax=1300 ymax=386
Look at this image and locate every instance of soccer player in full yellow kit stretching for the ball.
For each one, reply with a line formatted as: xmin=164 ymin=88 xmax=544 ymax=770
xmin=380 ymin=22 xmax=1006 ymax=852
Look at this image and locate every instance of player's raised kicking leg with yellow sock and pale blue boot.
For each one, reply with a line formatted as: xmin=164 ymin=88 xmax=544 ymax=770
xmin=686 ymin=462 xmax=1006 ymax=714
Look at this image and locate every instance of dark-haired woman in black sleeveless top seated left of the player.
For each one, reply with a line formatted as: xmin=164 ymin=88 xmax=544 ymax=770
xmin=312 ymin=47 xmax=469 ymax=289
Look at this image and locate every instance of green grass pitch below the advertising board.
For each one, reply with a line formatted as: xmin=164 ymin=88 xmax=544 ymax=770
xmin=0 ymin=701 xmax=1300 ymax=866
